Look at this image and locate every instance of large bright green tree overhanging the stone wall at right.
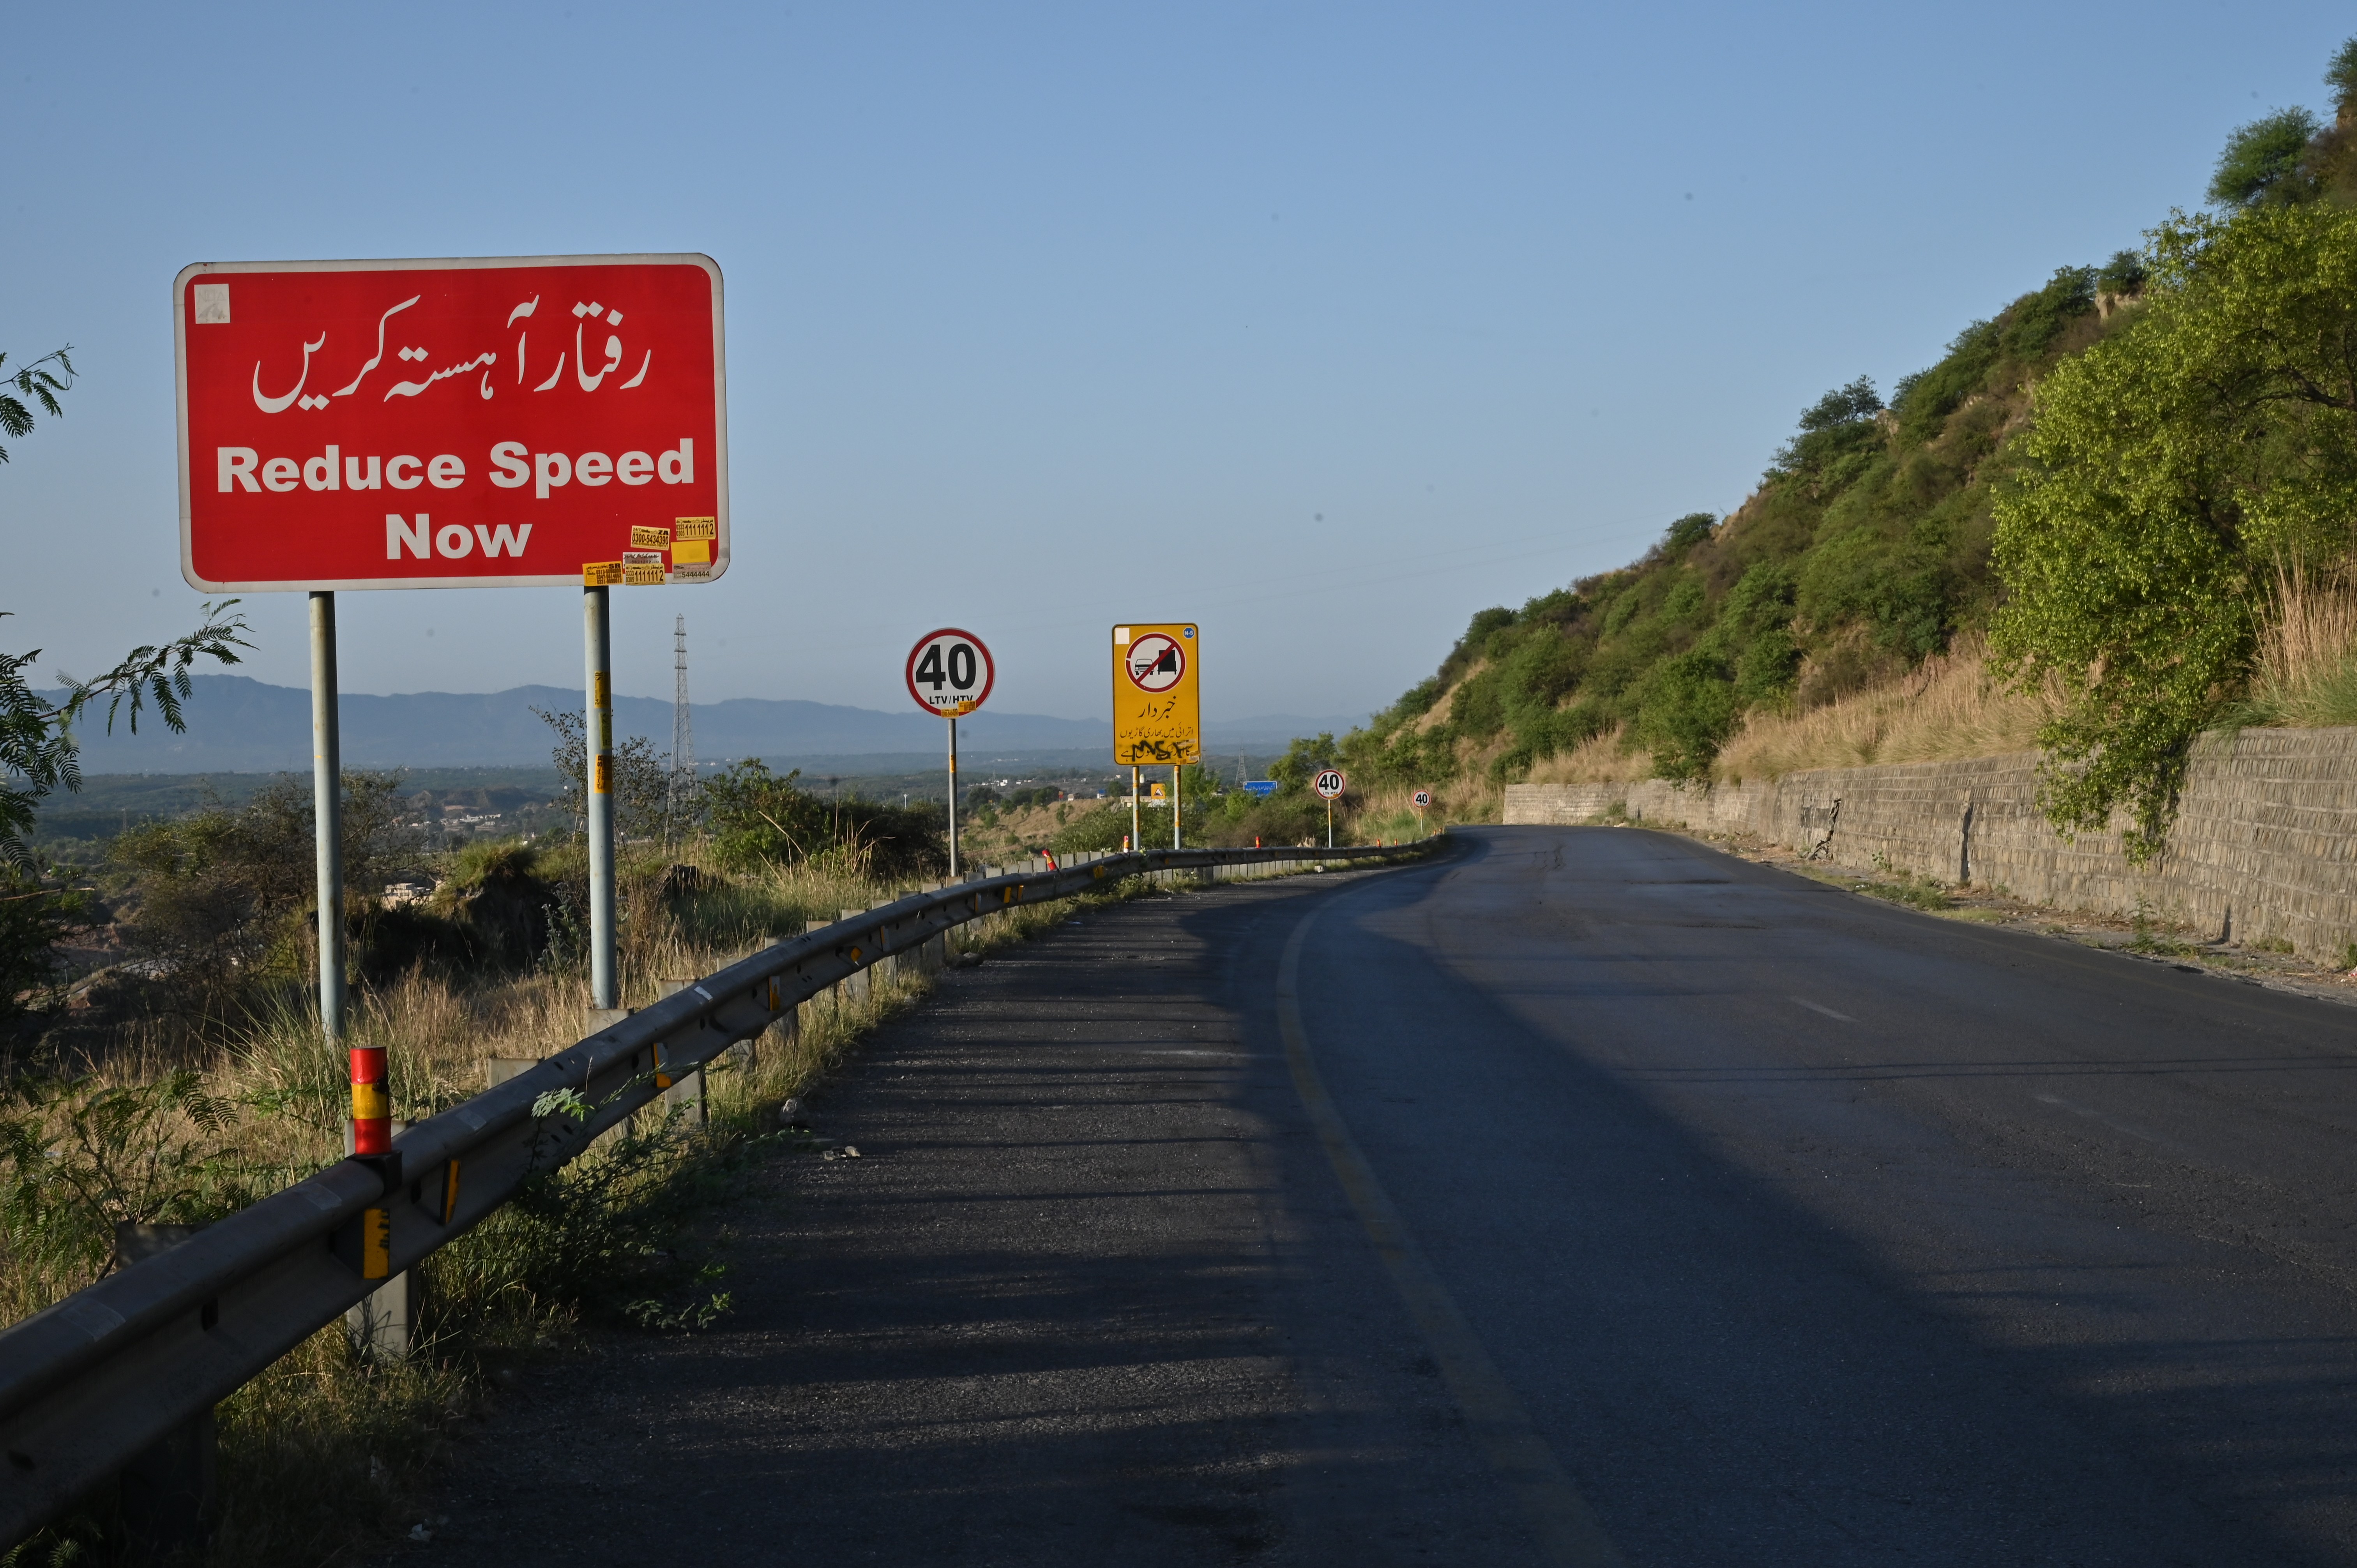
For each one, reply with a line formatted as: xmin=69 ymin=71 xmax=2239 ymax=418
xmin=1992 ymin=203 xmax=2357 ymax=861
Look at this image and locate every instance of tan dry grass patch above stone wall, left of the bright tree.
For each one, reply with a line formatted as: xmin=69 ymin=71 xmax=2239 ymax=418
xmin=1714 ymin=637 xmax=2051 ymax=783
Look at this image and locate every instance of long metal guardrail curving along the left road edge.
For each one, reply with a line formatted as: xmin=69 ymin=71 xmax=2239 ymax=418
xmin=0 ymin=837 xmax=1438 ymax=1544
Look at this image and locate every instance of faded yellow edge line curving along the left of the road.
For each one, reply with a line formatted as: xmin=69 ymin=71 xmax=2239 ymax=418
xmin=1277 ymin=913 xmax=1626 ymax=1568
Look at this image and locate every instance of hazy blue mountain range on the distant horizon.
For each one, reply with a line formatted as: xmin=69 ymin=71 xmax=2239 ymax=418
xmin=55 ymin=675 xmax=1362 ymax=773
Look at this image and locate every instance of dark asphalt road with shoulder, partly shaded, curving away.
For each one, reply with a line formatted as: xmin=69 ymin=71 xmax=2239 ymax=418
xmin=401 ymin=828 xmax=2357 ymax=1568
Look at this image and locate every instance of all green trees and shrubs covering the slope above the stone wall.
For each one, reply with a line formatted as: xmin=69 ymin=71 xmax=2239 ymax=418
xmin=1301 ymin=40 xmax=2357 ymax=858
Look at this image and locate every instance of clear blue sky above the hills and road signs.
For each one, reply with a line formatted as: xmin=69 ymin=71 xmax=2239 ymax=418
xmin=0 ymin=0 xmax=2357 ymax=735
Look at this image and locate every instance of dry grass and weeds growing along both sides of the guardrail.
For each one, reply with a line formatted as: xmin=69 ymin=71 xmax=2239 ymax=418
xmin=0 ymin=844 xmax=1079 ymax=1568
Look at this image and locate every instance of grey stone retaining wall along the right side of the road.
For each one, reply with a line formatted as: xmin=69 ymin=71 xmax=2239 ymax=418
xmin=1506 ymin=729 xmax=2357 ymax=957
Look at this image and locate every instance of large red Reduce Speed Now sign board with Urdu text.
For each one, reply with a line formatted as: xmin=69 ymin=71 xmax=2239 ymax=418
xmin=172 ymin=255 xmax=728 ymax=592
